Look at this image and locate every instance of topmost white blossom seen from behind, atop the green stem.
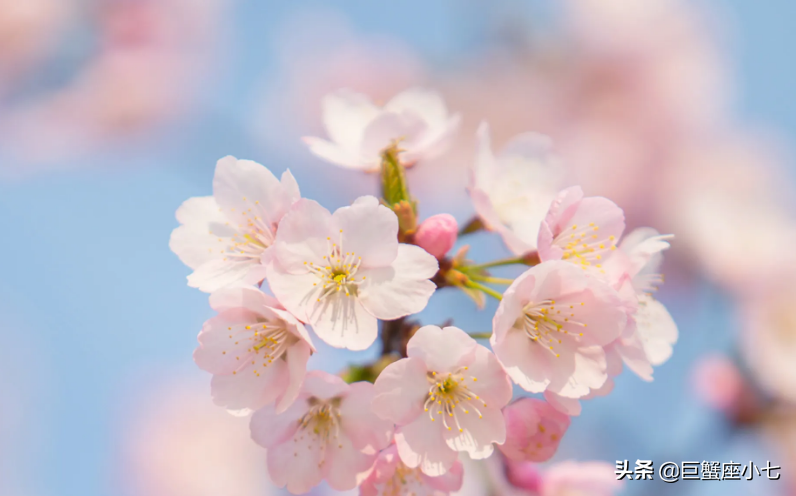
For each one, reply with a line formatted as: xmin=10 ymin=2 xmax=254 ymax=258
xmin=304 ymin=88 xmax=460 ymax=170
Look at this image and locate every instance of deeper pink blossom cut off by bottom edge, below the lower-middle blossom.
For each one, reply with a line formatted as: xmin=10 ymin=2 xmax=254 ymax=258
xmin=359 ymin=445 xmax=464 ymax=496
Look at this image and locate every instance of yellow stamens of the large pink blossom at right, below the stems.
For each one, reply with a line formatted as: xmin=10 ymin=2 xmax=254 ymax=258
xmin=514 ymin=300 xmax=587 ymax=357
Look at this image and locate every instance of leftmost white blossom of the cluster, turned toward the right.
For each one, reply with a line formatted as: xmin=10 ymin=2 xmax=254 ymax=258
xmin=169 ymin=156 xmax=300 ymax=293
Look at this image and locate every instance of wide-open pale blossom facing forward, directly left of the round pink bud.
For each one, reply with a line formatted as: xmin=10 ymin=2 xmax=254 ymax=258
xmin=268 ymin=196 xmax=439 ymax=350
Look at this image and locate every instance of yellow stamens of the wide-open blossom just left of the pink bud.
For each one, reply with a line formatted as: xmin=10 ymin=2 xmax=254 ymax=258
xmin=304 ymin=229 xmax=365 ymax=301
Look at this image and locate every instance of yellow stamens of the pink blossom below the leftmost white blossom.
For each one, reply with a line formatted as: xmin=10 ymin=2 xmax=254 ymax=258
xmin=221 ymin=321 xmax=298 ymax=377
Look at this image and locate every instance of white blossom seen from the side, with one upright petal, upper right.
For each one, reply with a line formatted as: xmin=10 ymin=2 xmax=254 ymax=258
xmin=468 ymin=122 xmax=563 ymax=255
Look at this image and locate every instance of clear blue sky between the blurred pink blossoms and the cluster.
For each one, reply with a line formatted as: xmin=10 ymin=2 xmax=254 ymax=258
xmin=0 ymin=0 xmax=796 ymax=496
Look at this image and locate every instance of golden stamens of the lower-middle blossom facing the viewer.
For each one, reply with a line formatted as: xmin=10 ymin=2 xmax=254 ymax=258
xmin=424 ymin=367 xmax=486 ymax=432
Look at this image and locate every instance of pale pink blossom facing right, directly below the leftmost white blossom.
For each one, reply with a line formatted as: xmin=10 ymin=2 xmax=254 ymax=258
xmin=194 ymin=288 xmax=314 ymax=413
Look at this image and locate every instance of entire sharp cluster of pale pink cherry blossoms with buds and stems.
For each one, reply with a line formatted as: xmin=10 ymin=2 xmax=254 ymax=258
xmin=170 ymin=89 xmax=677 ymax=496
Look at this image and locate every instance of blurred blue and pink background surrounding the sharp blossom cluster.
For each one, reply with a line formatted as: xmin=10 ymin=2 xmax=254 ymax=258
xmin=0 ymin=0 xmax=796 ymax=496
